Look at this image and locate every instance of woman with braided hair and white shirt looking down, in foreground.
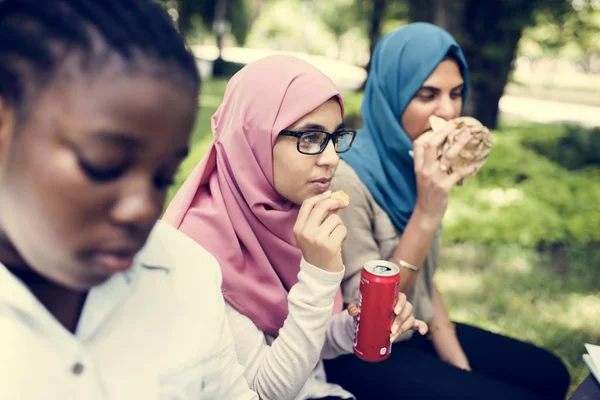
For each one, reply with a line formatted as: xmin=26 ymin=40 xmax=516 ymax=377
xmin=0 ymin=0 xmax=257 ymax=400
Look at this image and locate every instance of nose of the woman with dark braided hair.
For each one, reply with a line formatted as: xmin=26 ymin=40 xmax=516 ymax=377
xmin=111 ymin=177 xmax=162 ymax=231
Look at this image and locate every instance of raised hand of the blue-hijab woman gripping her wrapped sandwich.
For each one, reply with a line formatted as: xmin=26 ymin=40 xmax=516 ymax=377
xmin=413 ymin=124 xmax=475 ymax=228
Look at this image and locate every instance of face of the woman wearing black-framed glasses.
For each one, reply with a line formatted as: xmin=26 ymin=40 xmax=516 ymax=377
xmin=273 ymin=99 xmax=343 ymax=205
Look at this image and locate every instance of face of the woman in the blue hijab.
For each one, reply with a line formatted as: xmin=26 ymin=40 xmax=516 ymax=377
xmin=401 ymin=59 xmax=464 ymax=141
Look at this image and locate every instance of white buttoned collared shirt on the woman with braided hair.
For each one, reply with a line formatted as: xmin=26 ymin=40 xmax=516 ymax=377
xmin=0 ymin=221 xmax=258 ymax=400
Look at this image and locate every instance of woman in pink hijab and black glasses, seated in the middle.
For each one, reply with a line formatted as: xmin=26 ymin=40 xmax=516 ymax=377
xmin=164 ymin=56 xmax=427 ymax=400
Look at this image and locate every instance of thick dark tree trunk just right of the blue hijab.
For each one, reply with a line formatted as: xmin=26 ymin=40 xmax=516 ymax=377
xmin=410 ymin=0 xmax=534 ymax=129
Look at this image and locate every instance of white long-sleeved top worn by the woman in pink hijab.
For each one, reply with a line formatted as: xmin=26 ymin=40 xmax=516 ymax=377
xmin=226 ymin=260 xmax=354 ymax=400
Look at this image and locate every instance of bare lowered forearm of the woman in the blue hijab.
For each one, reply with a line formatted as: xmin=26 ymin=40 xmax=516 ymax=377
xmin=430 ymin=284 xmax=471 ymax=371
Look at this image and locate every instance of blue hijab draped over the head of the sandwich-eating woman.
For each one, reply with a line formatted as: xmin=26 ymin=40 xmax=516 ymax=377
xmin=342 ymin=22 xmax=468 ymax=231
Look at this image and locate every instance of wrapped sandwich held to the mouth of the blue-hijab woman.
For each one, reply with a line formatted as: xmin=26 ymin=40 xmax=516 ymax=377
xmin=429 ymin=116 xmax=494 ymax=183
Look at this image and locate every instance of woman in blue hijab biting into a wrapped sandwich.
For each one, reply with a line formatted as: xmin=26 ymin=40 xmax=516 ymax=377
xmin=325 ymin=23 xmax=569 ymax=400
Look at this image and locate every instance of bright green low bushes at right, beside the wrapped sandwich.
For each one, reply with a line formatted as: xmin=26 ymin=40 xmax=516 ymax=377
xmin=444 ymin=120 xmax=600 ymax=247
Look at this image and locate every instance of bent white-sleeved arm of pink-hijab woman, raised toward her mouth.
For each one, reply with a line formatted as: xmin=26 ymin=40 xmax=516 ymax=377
xmin=227 ymin=260 xmax=347 ymax=400
